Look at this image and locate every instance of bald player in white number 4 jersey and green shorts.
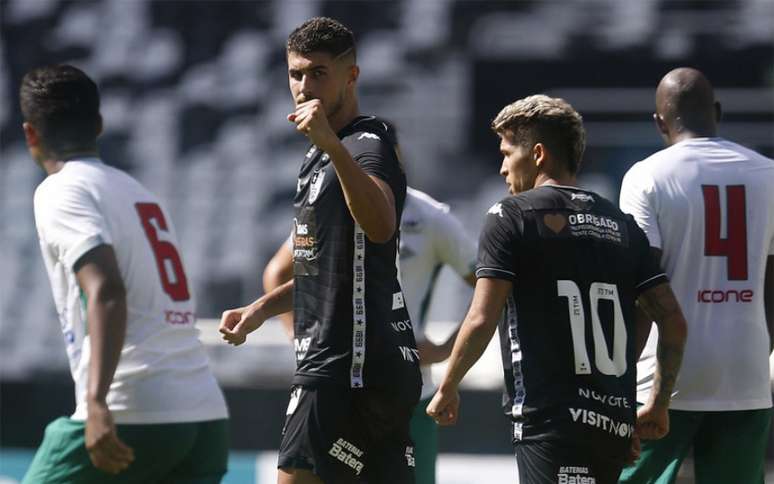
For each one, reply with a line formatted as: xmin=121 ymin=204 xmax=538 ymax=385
xmin=620 ymin=68 xmax=774 ymax=484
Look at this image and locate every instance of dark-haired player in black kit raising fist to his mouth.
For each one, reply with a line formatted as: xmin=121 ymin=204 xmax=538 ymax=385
xmin=220 ymin=18 xmax=421 ymax=484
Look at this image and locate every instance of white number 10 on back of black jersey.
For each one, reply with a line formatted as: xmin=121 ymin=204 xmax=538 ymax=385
xmin=556 ymin=280 xmax=627 ymax=376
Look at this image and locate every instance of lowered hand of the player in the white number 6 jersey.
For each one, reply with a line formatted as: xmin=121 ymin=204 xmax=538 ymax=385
xmin=86 ymin=402 xmax=134 ymax=474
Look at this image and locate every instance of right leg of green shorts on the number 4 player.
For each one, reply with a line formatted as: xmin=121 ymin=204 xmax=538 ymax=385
xmin=693 ymin=408 xmax=771 ymax=484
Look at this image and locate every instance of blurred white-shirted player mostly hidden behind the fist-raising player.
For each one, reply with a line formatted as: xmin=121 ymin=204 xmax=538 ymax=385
xmin=263 ymin=187 xmax=476 ymax=484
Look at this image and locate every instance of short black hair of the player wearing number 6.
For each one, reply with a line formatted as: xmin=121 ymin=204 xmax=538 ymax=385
xmin=19 ymin=64 xmax=101 ymax=153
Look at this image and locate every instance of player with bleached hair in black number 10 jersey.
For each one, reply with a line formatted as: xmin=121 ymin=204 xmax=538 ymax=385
xmin=427 ymin=95 xmax=686 ymax=484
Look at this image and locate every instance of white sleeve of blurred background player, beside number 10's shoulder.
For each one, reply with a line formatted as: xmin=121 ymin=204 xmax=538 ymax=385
xmin=433 ymin=207 xmax=476 ymax=277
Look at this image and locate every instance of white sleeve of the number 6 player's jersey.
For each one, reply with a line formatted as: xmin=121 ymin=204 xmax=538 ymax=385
xmin=34 ymin=181 xmax=112 ymax=269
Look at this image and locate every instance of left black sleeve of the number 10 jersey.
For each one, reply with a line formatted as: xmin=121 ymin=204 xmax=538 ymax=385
xmin=476 ymin=201 xmax=523 ymax=281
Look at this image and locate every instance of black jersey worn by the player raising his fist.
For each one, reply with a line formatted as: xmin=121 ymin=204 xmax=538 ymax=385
xmin=293 ymin=116 xmax=421 ymax=399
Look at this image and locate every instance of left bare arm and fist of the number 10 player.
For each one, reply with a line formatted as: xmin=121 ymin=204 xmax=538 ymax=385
xmin=427 ymin=278 xmax=513 ymax=425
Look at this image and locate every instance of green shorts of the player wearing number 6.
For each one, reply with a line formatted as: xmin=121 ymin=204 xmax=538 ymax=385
xmin=22 ymin=417 xmax=228 ymax=484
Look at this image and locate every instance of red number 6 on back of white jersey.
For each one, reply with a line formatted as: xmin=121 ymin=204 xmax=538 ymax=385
xmin=135 ymin=203 xmax=191 ymax=301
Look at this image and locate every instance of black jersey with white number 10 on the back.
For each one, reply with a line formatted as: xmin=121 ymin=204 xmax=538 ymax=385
xmin=476 ymin=185 xmax=666 ymax=457
